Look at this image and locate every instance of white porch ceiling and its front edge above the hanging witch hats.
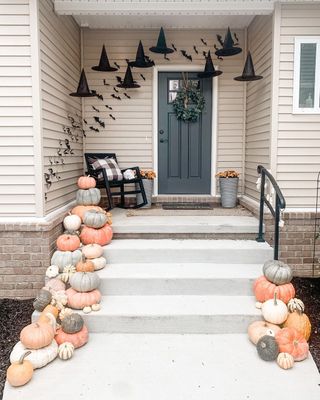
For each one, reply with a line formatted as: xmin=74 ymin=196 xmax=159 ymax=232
xmin=54 ymin=0 xmax=275 ymax=29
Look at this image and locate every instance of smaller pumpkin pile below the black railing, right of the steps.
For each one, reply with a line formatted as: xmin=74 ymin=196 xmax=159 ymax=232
xmin=248 ymin=260 xmax=311 ymax=369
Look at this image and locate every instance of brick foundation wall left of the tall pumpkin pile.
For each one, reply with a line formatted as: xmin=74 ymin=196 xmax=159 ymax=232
xmin=0 ymin=213 xmax=65 ymax=299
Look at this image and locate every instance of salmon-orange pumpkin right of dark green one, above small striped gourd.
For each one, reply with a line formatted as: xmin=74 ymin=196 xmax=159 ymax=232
xmin=276 ymin=328 xmax=309 ymax=361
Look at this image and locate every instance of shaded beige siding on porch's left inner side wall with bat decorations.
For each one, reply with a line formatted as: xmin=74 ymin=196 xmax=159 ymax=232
xmin=39 ymin=0 xmax=83 ymax=213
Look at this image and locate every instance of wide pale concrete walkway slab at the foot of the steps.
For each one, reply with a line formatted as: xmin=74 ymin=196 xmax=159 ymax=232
xmin=3 ymin=333 xmax=320 ymax=400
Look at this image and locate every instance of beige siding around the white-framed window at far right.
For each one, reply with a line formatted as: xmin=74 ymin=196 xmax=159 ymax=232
xmin=277 ymin=4 xmax=320 ymax=207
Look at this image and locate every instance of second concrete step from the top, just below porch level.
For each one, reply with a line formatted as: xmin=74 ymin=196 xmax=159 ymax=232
xmin=104 ymin=239 xmax=273 ymax=264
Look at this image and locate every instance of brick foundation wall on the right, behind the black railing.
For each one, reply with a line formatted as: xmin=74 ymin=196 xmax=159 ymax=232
xmin=240 ymin=200 xmax=320 ymax=277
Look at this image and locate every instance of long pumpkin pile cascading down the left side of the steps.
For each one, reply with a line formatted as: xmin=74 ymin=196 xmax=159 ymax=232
xmin=7 ymin=177 xmax=112 ymax=386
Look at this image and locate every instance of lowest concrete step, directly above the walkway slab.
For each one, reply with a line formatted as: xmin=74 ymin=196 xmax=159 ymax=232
xmin=81 ymin=295 xmax=261 ymax=334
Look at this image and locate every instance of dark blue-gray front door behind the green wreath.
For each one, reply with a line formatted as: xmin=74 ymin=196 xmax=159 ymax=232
xmin=158 ymin=72 xmax=212 ymax=194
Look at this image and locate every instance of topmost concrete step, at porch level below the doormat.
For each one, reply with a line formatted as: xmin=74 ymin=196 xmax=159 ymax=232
xmin=112 ymin=210 xmax=259 ymax=239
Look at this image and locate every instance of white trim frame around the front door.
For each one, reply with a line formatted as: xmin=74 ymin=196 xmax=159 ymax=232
xmin=152 ymin=64 xmax=218 ymax=196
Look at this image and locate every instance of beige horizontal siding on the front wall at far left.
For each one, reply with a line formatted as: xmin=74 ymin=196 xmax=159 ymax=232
xmin=0 ymin=0 xmax=36 ymax=216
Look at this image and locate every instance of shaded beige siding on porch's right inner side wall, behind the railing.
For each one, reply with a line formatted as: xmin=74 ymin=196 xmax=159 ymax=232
xmin=245 ymin=16 xmax=272 ymax=200
